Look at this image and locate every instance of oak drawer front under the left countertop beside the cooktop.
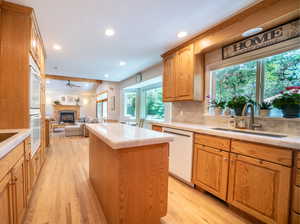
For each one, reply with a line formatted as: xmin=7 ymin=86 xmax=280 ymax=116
xmin=0 ymin=142 xmax=24 ymax=180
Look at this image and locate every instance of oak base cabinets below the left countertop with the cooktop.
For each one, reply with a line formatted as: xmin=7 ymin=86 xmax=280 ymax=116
xmin=0 ymin=137 xmax=42 ymax=224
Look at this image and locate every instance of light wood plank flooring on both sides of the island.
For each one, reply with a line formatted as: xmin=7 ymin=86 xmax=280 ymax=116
xmin=24 ymin=136 xmax=249 ymax=224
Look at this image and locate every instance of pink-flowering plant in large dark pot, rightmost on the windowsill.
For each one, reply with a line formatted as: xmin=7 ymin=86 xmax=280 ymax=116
xmin=272 ymin=86 xmax=300 ymax=118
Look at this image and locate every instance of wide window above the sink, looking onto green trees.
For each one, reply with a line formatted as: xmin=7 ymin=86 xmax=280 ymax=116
xmin=210 ymin=49 xmax=300 ymax=116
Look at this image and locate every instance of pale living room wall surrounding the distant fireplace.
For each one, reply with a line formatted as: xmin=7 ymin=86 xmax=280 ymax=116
xmin=46 ymin=90 xmax=96 ymax=118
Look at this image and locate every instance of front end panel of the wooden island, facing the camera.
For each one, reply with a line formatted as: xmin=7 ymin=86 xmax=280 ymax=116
xmin=119 ymin=143 xmax=169 ymax=224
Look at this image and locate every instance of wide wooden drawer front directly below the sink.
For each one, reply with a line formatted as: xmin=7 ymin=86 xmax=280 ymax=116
xmin=231 ymin=140 xmax=293 ymax=167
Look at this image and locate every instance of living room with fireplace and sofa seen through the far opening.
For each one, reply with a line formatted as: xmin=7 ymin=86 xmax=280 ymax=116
xmin=45 ymin=76 xmax=100 ymax=137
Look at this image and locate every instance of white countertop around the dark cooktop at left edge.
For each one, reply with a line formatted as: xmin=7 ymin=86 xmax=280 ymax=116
xmin=0 ymin=129 xmax=30 ymax=159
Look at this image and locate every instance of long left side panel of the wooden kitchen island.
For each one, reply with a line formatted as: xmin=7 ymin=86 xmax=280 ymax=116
xmin=89 ymin=133 xmax=119 ymax=224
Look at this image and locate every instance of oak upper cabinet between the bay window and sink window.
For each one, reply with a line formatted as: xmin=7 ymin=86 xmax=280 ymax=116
xmin=163 ymin=44 xmax=204 ymax=102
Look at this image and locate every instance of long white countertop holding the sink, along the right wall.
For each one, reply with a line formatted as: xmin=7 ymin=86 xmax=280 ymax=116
xmin=152 ymin=122 xmax=300 ymax=151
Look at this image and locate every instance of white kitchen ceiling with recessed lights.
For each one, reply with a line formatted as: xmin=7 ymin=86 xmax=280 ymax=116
xmin=8 ymin=0 xmax=256 ymax=81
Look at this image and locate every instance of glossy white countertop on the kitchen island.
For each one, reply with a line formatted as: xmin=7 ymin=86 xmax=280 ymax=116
xmin=86 ymin=123 xmax=174 ymax=149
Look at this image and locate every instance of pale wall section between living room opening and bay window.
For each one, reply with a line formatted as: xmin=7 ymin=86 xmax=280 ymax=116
xmin=95 ymin=81 xmax=120 ymax=120
